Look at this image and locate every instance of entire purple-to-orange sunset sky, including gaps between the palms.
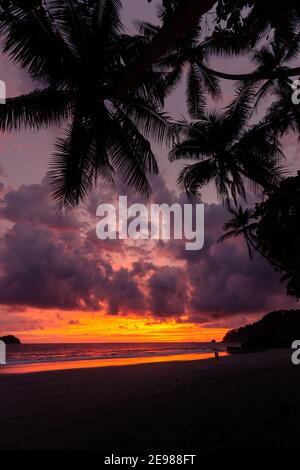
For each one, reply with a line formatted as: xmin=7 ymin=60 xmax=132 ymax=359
xmin=0 ymin=0 xmax=298 ymax=342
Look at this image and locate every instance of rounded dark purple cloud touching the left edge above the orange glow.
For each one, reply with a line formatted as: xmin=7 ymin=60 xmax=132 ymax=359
xmin=0 ymin=222 xmax=105 ymax=310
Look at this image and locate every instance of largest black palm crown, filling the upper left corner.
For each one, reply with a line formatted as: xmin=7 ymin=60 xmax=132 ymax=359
xmin=0 ymin=0 xmax=169 ymax=210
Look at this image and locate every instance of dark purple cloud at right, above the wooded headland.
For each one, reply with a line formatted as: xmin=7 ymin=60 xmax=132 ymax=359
xmin=158 ymin=204 xmax=296 ymax=323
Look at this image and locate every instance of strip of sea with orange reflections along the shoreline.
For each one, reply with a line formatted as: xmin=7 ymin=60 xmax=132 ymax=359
xmin=0 ymin=342 xmax=224 ymax=374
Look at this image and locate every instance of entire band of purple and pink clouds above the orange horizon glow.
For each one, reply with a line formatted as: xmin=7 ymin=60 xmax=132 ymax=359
xmin=0 ymin=178 xmax=292 ymax=324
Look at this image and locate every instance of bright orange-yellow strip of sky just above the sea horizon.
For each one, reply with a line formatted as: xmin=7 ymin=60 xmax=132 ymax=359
xmin=5 ymin=309 xmax=228 ymax=343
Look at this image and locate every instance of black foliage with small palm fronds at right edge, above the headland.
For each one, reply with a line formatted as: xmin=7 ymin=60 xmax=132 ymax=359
xmin=219 ymin=173 xmax=300 ymax=299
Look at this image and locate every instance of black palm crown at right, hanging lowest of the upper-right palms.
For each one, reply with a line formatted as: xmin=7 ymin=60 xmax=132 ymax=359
xmin=169 ymin=87 xmax=285 ymax=202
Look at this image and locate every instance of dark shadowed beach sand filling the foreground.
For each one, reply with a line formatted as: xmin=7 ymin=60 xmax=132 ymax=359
xmin=0 ymin=350 xmax=300 ymax=454
